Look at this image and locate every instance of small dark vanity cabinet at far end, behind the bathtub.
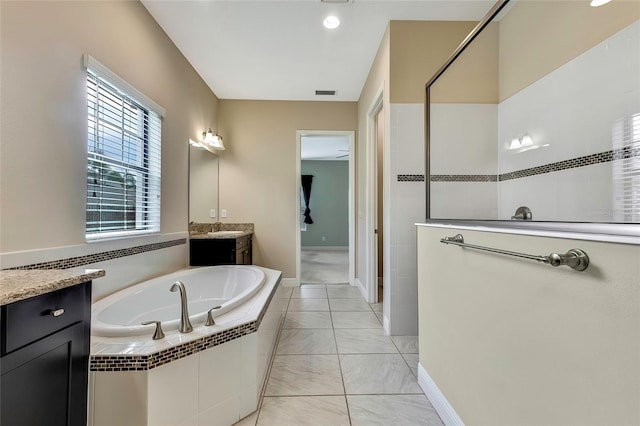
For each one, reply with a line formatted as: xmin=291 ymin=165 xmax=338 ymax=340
xmin=189 ymin=235 xmax=253 ymax=266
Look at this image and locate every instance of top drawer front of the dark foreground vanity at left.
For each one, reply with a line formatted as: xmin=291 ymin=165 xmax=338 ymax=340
xmin=0 ymin=283 xmax=90 ymax=355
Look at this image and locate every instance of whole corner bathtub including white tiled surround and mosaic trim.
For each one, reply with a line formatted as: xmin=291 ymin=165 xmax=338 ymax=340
xmin=88 ymin=265 xmax=290 ymax=426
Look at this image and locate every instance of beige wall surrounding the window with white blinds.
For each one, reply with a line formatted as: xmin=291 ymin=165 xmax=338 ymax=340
xmin=1 ymin=1 xmax=218 ymax=252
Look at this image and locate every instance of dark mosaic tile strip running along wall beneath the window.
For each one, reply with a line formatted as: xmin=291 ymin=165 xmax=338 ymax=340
xmin=6 ymin=238 xmax=187 ymax=270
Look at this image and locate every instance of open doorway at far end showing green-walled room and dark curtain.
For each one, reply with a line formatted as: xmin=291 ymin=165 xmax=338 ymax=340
xmin=296 ymin=130 xmax=355 ymax=285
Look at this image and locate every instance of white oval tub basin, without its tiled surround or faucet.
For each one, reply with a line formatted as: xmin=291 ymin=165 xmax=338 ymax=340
xmin=91 ymin=265 xmax=265 ymax=337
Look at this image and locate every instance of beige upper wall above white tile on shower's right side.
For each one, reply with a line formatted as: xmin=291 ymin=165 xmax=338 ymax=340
xmin=499 ymin=0 xmax=640 ymax=101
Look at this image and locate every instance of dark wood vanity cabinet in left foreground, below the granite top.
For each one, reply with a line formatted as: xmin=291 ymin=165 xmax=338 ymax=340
xmin=0 ymin=282 xmax=91 ymax=426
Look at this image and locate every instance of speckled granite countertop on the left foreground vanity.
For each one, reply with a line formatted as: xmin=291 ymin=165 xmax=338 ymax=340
xmin=0 ymin=268 xmax=105 ymax=305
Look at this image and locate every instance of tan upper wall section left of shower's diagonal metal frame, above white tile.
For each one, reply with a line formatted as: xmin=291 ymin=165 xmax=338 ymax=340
xmin=389 ymin=21 xmax=476 ymax=103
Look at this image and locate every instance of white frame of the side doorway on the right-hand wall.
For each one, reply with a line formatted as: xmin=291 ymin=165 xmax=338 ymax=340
xmin=365 ymin=87 xmax=388 ymax=303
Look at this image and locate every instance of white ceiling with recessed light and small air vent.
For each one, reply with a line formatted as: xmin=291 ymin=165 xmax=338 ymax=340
xmin=142 ymin=0 xmax=494 ymax=101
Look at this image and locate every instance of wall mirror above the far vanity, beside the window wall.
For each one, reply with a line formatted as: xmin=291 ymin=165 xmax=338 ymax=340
xmin=189 ymin=145 xmax=219 ymax=223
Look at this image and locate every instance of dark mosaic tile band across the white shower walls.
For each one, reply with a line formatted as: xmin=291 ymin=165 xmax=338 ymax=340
xmin=424 ymin=146 xmax=640 ymax=182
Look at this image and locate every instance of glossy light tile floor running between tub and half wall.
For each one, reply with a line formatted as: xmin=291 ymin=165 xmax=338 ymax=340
xmin=237 ymin=284 xmax=442 ymax=426
